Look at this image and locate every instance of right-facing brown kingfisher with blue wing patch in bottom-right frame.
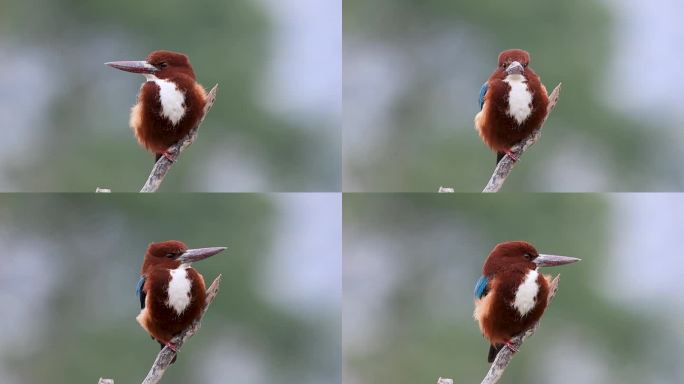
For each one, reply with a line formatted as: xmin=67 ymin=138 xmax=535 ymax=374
xmin=473 ymin=241 xmax=580 ymax=363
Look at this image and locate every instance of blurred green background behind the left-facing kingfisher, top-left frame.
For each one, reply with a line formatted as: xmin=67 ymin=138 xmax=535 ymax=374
xmin=0 ymin=0 xmax=342 ymax=192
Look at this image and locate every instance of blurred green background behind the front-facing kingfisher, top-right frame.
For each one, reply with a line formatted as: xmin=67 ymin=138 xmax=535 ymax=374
xmin=343 ymin=0 xmax=684 ymax=192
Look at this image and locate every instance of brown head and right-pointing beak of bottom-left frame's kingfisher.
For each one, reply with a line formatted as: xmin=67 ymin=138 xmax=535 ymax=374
xmin=143 ymin=240 xmax=226 ymax=269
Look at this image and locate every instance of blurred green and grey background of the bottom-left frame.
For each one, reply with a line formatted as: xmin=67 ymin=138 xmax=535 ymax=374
xmin=0 ymin=194 xmax=341 ymax=384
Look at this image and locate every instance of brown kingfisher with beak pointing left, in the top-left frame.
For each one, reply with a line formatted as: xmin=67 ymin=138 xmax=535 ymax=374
xmin=105 ymin=51 xmax=207 ymax=162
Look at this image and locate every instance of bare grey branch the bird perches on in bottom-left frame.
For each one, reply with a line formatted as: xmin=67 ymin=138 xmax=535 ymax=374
xmin=98 ymin=275 xmax=221 ymax=384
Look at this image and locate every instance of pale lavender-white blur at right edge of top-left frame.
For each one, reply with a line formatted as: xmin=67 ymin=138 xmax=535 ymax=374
xmin=254 ymin=0 xmax=342 ymax=121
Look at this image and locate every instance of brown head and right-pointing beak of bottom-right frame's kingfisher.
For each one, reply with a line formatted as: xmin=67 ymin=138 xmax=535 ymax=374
xmin=483 ymin=241 xmax=581 ymax=276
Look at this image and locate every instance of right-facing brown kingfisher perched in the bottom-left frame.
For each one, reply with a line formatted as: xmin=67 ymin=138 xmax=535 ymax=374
xmin=136 ymin=240 xmax=226 ymax=361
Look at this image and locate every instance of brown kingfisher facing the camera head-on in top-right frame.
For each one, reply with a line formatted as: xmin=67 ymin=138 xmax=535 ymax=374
xmin=475 ymin=49 xmax=549 ymax=164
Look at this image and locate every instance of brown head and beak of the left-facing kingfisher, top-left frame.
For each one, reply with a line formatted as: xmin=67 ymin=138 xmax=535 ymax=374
xmin=105 ymin=51 xmax=195 ymax=80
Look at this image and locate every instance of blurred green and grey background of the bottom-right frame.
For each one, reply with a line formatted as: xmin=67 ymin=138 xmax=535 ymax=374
xmin=342 ymin=194 xmax=684 ymax=384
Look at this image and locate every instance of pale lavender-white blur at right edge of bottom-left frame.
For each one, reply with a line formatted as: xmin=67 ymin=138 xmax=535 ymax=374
xmin=260 ymin=193 xmax=342 ymax=318
